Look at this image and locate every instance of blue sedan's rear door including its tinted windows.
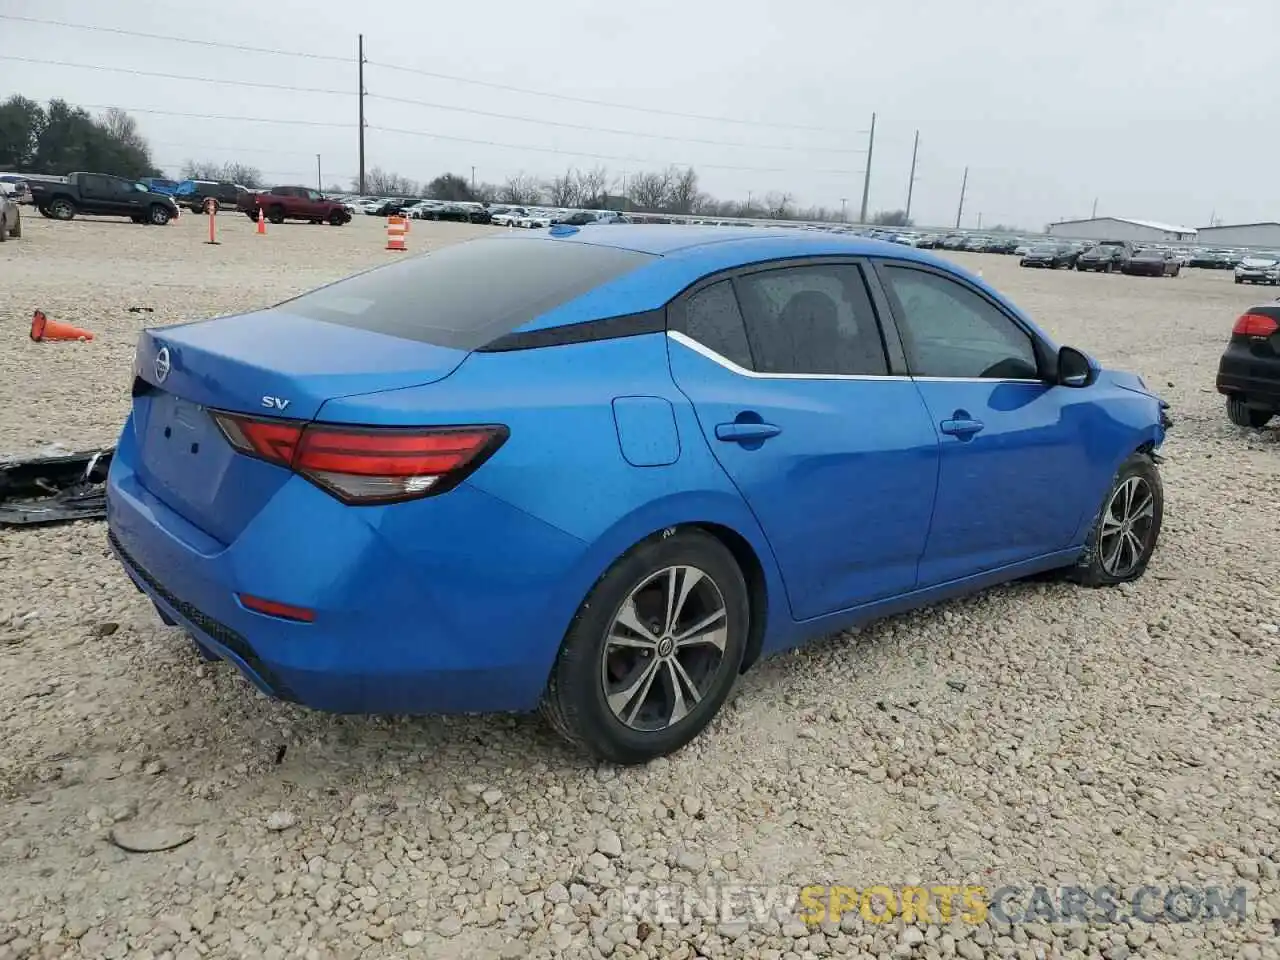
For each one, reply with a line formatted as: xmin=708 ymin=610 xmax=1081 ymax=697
xmin=668 ymin=260 xmax=938 ymax=620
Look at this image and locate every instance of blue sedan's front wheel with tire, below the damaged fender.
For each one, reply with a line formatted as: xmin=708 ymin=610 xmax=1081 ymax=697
xmin=1068 ymin=452 xmax=1165 ymax=586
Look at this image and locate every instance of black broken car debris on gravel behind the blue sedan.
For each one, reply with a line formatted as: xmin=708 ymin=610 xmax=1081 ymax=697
xmin=0 ymin=447 xmax=115 ymax=526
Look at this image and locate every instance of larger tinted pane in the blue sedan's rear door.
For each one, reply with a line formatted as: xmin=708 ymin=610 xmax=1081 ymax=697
xmin=733 ymin=264 xmax=888 ymax=376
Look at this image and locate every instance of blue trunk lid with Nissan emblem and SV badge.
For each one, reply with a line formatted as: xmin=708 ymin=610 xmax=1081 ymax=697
xmin=133 ymin=310 xmax=467 ymax=544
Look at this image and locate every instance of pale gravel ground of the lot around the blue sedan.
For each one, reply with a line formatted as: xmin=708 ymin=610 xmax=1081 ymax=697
xmin=0 ymin=216 xmax=1280 ymax=960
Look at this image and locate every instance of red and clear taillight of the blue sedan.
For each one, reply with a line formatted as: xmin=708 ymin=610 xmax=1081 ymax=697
xmin=214 ymin=412 xmax=507 ymax=504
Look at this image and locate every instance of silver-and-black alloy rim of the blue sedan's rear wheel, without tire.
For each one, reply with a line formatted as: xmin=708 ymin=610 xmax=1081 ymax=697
xmin=600 ymin=566 xmax=728 ymax=732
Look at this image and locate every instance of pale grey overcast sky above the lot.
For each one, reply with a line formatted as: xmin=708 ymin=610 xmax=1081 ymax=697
xmin=0 ymin=0 xmax=1280 ymax=229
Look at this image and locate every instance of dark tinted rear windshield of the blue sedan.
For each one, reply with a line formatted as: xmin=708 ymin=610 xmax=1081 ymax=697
xmin=279 ymin=238 xmax=654 ymax=351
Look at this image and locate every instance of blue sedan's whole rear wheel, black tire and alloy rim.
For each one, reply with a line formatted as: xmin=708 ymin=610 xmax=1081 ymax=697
xmin=541 ymin=530 xmax=750 ymax=764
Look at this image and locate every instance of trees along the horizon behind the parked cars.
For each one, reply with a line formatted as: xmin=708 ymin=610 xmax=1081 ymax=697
xmin=0 ymin=95 xmax=910 ymax=227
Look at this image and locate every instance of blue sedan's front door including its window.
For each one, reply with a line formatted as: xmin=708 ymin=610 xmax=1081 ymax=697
xmin=876 ymin=261 xmax=1097 ymax=588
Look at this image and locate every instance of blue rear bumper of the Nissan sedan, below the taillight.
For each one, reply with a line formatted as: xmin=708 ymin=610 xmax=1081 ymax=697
xmin=108 ymin=426 xmax=585 ymax=713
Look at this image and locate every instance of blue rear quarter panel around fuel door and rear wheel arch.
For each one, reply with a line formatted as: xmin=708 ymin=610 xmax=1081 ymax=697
xmin=319 ymin=333 xmax=790 ymax=666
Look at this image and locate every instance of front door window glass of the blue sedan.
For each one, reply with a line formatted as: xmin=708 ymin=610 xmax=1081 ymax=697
xmin=883 ymin=266 xmax=1039 ymax=380
